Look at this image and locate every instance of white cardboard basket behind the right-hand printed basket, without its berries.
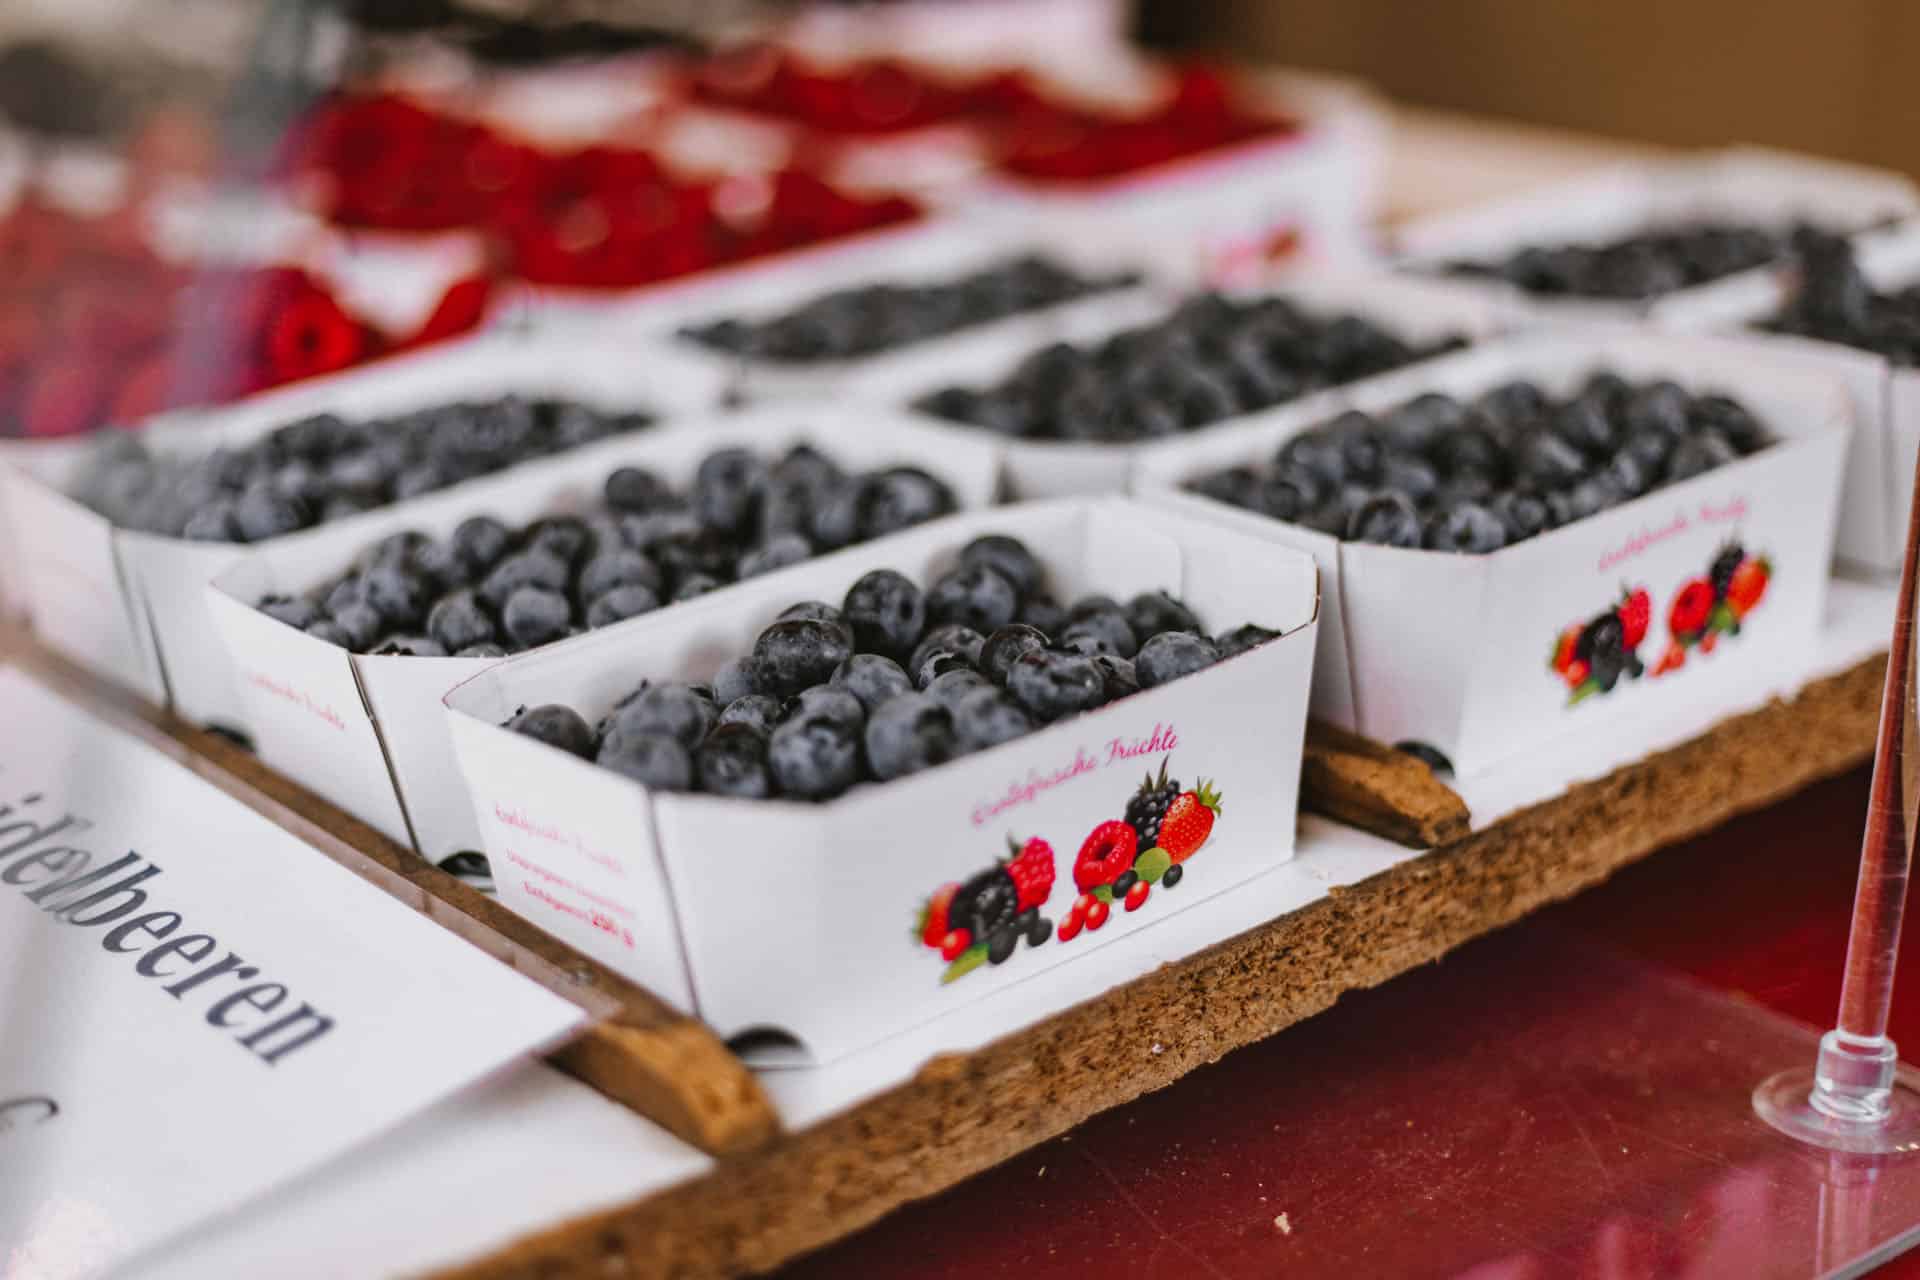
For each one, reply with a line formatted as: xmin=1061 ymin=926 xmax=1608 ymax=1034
xmin=841 ymin=269 xmax=1501 ymax=499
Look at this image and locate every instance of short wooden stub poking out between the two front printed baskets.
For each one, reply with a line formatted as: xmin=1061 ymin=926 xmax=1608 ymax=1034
xmin=1300 ymin=720 xmax=1469 ymax=848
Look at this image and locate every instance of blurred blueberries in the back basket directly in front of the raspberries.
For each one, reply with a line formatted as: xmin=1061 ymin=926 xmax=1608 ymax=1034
xmin=680 ymin=253 xmax=1140 ymax=363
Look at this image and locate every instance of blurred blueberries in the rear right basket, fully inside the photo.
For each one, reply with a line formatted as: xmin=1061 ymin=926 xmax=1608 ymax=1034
xmin=1444 ymin=221 xmax=1788 ymax=301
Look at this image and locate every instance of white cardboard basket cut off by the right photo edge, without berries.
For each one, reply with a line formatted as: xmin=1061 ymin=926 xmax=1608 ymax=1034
xmin=1651 ymin=223 xmax=1920 ymax=574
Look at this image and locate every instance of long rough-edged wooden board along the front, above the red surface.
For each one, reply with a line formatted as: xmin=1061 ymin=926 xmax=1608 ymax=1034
xmin=444 ymin=658 xmax=1885 ymax=1280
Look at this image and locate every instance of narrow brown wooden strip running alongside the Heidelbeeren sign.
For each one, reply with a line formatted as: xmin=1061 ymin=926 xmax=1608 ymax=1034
xmin=0 ymin=622 xmax=780 ymax=1155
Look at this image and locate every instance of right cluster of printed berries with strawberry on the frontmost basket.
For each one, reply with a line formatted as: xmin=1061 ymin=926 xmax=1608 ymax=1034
xmin=1056 ymin=758 xmax=1221 ymax=942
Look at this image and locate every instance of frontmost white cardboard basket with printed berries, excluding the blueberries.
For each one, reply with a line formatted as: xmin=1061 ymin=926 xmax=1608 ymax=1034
xmin=447 ymin=499 xmax=1317 ymax=1063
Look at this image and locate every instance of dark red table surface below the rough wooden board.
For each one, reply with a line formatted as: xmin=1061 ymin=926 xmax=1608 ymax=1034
xmin=783 ymin=770 xmax=1920 ymax=1280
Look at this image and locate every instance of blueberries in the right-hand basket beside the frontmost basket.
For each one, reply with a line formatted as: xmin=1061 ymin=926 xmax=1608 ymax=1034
xmin=1187 ymin=372 xmax=1772 ymax=555
